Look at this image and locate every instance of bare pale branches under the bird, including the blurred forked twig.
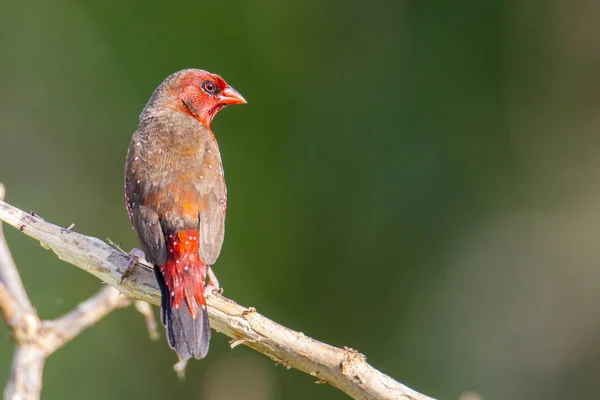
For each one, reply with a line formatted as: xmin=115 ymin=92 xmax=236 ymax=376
xmin=0 ymin=185 xmax=431 ymax=400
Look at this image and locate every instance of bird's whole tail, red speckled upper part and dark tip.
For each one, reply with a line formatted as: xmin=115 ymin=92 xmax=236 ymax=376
xmin=154 ymin=230 xmax=210 ymax=360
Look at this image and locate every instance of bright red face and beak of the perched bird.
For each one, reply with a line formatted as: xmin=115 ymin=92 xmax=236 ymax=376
xmin=174 ymin=70 xmax=246 ymax=128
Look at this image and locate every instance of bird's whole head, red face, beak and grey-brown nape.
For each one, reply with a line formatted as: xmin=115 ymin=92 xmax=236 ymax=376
xmin=142 ymin=69 xmax=246 ymax=127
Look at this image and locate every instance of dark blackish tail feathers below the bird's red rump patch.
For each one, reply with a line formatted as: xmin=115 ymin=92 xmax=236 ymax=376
xmin=154 ymin=267 xmax=210 ymax=360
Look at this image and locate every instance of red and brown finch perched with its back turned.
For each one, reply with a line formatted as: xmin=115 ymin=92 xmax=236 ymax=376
xmin=125 ymin=69 xmax=246 ymax=365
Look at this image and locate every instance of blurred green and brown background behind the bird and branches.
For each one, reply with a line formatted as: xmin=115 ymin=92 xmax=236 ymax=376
xmin=0 ymin=0 xmax=600 ymax=400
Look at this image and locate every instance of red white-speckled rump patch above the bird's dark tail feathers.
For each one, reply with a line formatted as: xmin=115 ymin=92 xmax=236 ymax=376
xmin=159 ymin=230 xmax=206 ymax=319
